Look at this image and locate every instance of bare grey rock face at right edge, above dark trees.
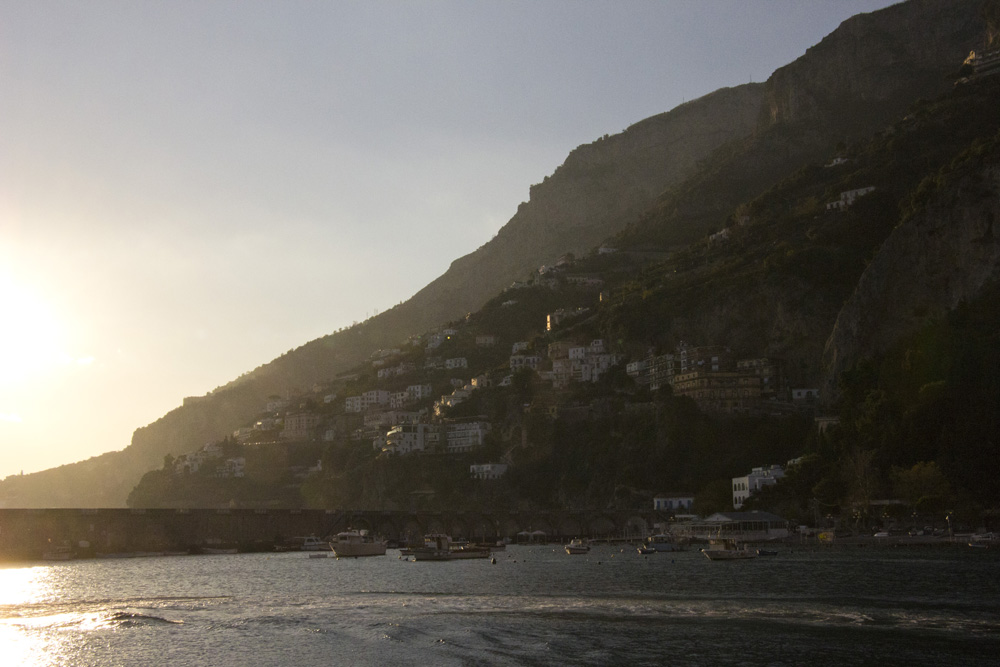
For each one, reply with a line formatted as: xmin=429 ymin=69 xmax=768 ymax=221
xmin=824 ymin=151 xmax=1000 ymax=390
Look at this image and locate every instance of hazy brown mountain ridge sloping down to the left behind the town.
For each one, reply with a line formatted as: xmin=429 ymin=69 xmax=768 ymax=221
xmin=0 ymin=0 xmax=992 ymax=506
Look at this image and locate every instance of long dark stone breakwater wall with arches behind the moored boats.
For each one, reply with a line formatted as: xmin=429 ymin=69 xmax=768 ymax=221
xmin=0 ymin=508 xmax=667 ymax=561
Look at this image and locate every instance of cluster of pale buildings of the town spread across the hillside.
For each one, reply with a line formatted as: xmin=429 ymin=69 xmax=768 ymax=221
xmin=172 ymin=253 xmax=819 ymax=514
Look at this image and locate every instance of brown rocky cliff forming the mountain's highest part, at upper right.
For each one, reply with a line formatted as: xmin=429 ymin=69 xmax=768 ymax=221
xmin=621 ymin=0 xmax=995 ymax=247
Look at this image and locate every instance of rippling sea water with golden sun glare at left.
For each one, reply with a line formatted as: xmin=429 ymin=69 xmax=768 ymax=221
xmin=0 ymin=545 xmax=1000 ymax=667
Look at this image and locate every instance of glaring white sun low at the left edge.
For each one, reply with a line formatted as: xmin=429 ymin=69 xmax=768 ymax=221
xmin=0 ymin=276 xmax=68 ymax=384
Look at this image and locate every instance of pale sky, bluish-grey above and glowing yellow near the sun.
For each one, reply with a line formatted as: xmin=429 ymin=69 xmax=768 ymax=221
xmin=0 ymin=0 xmax=893 ymax=478
